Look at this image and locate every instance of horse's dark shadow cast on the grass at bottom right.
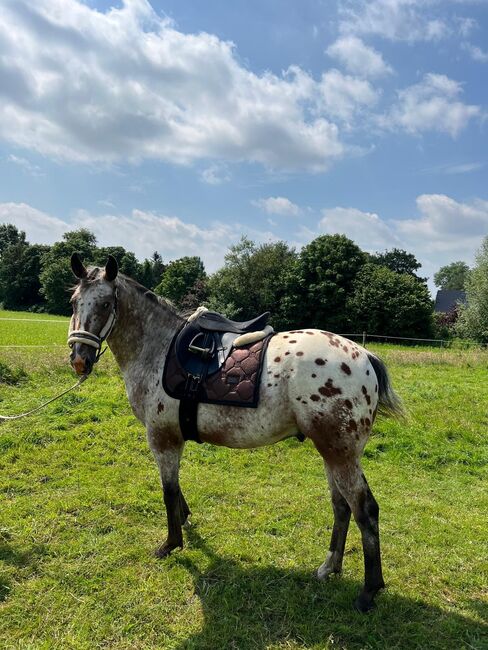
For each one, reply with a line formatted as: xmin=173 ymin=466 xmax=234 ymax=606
xmin=175 ymin=529 xmax=488 ymax=650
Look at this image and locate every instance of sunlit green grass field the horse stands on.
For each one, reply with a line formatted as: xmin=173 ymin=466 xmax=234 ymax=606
xmin=0 ymin=312 xmax=488 ymax=650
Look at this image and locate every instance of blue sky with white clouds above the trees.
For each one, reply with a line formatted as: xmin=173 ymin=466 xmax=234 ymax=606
xmin=0 ymin=0 xmax=488 ymax=289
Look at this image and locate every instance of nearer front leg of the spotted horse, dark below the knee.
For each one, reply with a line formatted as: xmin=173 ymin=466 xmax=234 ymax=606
xmin=148 ymin=431 xmax=186 ymax=558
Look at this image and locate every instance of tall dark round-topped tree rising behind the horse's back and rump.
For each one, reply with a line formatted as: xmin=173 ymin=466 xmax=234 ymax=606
xmin=295 ymin=235 xmax=367 ymax=332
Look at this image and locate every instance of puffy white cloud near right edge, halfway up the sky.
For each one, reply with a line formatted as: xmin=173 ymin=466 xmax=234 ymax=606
xmin=379 ymin=73 xmax=481 ymax=137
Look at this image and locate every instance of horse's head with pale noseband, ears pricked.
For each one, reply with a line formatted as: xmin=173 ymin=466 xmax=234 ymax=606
xmin=68 ymin=253 xmax=118 ymax=375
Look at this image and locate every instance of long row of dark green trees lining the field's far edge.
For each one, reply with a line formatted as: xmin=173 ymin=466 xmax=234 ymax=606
xmin=0 ymin=224 xmax=488 ymax=337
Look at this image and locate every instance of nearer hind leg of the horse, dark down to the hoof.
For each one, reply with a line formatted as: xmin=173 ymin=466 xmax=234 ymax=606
xmin=329 ymin=461 xmax=385 ymax=612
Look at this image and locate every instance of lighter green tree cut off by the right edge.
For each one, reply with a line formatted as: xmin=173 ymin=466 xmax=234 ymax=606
xmin=457 ymin=236 xmax=488 ymax=345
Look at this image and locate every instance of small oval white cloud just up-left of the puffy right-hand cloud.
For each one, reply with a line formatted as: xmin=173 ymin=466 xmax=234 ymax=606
xmin=326 ymin=36 xmax=393 ymax=77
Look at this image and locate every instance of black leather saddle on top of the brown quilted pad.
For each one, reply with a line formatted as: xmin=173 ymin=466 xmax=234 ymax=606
xmin=175 ymin=311 xmax=269 ymax=384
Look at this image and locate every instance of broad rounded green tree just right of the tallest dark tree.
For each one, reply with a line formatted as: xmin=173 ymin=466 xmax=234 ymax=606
xmin=347 ymin=264 xmax=433 ymax=337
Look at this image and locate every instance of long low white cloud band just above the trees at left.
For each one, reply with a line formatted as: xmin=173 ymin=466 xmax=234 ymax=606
xmin=0 ymin=203 xmax=275 ymax=272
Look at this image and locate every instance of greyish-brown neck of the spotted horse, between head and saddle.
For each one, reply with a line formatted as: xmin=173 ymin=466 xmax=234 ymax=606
xmin=107 ymin=279 xmax=182 ymax=374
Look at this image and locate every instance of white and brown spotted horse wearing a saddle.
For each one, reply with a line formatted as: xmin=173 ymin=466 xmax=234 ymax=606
xmin=71 ymin=255 xmax=401 ymax=612
